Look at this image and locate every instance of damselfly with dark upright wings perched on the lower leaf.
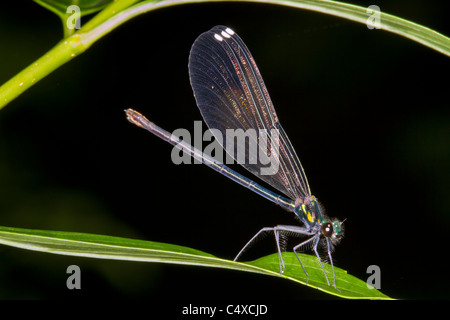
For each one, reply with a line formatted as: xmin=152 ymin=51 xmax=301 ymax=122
xmin=126 ymin=26 xmax=344 ymax=288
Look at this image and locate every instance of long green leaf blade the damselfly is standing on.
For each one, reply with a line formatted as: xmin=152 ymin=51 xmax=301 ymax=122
xmin=0 ymin=227 xmax=390 ymax=299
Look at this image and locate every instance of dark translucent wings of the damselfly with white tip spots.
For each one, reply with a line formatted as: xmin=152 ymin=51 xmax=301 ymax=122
xmin=189 ymin=26 xmax=311 ymax=200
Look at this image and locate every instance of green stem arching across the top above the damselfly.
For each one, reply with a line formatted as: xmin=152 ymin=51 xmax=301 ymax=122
xmin=0 ymin=0 xmax=450 ymax=109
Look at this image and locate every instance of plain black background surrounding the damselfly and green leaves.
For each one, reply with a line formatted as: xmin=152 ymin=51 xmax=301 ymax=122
xmin=0 ymin=0 xmax=450 ymax=299
